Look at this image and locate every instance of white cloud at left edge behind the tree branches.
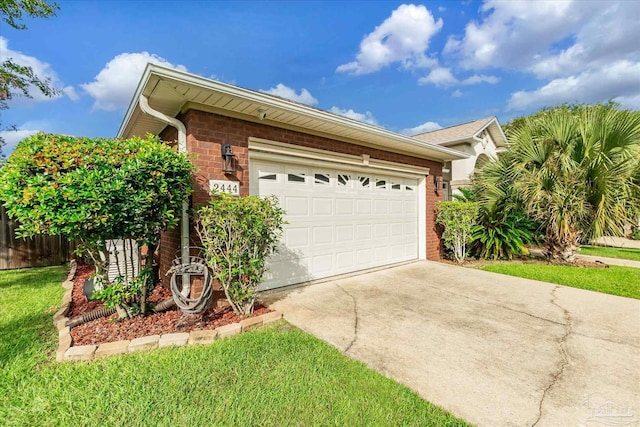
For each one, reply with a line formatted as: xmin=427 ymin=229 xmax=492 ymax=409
xmin=0 ymin=36 xmax=78 ymax=103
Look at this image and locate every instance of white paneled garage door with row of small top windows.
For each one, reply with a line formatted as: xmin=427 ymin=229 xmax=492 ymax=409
xmin=251 ymin=160 xmax=418 ymax=289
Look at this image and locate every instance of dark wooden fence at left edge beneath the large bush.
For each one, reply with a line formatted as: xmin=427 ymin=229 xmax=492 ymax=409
xmin=0 ymin=205 xmax=74 ymax=270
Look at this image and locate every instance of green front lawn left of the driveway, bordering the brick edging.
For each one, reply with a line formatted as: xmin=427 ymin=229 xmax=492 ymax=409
xmin=0 ymin=267 xmax=467 ymax=426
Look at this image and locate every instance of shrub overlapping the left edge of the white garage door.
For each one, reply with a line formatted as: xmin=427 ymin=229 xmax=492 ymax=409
xmin=197 ymin=193 xmax=284 ymax=316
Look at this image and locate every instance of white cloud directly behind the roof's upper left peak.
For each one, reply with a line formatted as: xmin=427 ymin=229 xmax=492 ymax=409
xmin=80 ymin=52 xmax=187 ymax=111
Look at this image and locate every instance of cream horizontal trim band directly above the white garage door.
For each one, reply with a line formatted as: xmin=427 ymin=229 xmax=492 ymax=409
xmin=249 ymin=137 xmax=429 ymax=178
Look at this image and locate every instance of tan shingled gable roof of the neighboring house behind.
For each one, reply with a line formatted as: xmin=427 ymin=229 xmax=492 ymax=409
xmin=413 ymin=116 xmax=507 ymax=147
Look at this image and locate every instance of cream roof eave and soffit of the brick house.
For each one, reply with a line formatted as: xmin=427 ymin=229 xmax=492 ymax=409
xmin=118 ymin=64 xmax=470 ymax=161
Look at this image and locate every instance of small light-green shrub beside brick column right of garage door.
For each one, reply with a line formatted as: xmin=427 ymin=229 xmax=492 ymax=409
xmin=436 ymin=201 xmax=478 ymax=264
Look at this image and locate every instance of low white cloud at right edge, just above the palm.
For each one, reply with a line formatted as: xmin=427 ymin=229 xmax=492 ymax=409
xmin=507 ymin=60 xmax=640 ymax=110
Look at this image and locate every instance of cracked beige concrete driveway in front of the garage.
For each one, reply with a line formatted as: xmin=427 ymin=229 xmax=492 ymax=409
xmin=266 ymin=261 xmax=640 ymax=426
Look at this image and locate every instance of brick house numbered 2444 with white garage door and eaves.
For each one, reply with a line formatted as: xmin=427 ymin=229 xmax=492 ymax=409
xmin=118 ymin=64 xmax=468 ymax=289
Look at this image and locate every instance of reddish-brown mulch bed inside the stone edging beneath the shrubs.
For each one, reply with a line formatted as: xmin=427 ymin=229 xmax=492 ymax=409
xmin=67 ymin=261 xmax=272 ymax=345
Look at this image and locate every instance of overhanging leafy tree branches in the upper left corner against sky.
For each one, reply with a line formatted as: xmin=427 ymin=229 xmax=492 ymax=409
xmin=0 ymin=0 xmax=60 ymax=160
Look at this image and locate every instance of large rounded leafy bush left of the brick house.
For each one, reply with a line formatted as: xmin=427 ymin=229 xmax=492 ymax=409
xmin=0 ymin=133 xmax=193 ymax=314
